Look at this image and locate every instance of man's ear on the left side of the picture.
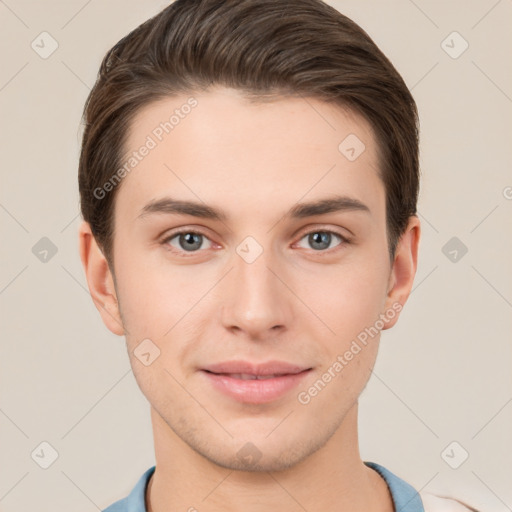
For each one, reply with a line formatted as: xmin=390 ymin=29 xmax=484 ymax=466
xmin=78 ymin=221 xmax=125 ymax=336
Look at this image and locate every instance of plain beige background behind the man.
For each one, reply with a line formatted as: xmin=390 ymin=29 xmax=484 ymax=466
xmin=0 ymin=0 xmax=512 ymax=512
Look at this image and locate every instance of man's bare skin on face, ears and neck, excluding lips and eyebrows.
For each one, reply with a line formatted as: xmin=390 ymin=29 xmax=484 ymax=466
xmin=79 ymin=87 xmax=420 ymax=512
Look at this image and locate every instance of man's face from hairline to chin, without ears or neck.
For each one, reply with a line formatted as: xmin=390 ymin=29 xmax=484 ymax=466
xmin=103 ymin=88 xmax=404 ymax=471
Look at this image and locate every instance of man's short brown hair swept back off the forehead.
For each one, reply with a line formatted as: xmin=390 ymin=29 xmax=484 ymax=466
xmin=78 ymin=0 xmax=419 ymax=265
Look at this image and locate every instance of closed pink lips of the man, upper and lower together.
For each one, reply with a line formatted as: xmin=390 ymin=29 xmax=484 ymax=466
xmin=201 ymin=361 xmax=312 ymax=404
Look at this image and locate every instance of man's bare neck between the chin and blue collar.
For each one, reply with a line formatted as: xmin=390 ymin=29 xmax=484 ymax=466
xmin=146 ymin=403 xmax=394 ymax=512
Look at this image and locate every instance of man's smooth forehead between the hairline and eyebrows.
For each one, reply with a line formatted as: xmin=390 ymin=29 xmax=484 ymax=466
xmin=116 ymin=88 xmax=383 ymax=222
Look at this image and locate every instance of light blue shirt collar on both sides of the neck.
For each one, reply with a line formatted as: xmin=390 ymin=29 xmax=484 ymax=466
xmin=103 ymin=462 xmax=425 ymax=512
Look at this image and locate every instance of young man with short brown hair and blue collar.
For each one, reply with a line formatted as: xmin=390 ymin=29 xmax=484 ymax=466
xmin=79 ymin=0 xmax=476 ymax=512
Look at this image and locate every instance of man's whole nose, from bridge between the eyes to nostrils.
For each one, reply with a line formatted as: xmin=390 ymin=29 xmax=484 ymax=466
xmin=222 ymin=237 xmax=289 ymax=337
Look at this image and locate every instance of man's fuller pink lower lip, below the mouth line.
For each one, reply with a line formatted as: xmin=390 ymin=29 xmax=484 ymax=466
xmin=202 ymin=370 xmax=311 ymax=404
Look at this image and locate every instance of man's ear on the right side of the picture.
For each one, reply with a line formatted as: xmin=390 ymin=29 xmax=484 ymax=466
xmin=382 ymin=215 xmax=421 ymax=330
